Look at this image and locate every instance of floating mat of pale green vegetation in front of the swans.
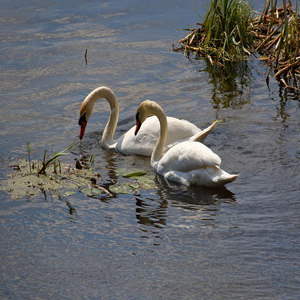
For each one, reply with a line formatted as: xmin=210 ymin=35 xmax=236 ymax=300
xmin=0 ymin=141 xmax=155 ymax=199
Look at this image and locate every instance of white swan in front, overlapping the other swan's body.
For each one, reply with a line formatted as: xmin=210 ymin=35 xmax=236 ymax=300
xmin=135 ymin=100 xmax=239 ymax=187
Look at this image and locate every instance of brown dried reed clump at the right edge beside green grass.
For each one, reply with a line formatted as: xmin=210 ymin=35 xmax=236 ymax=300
xmin=253 ymin=0 xmax=300 ymax=89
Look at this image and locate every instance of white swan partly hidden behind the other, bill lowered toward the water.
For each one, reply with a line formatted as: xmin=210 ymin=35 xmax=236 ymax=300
xmin=79 ymin=86 xmax=218 ymax=156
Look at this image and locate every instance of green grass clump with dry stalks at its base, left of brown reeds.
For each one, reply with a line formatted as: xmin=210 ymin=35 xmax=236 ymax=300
xmin=179 ymin=0 xmax=254 ymax=64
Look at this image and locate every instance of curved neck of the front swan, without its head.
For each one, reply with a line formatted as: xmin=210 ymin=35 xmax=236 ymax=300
xmin=151 ymin=106 xmax=168 ymax=167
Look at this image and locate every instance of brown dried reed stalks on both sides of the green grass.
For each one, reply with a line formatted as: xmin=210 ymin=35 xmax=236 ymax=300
xmin=173 ymin=0 xmax=300 ymax=89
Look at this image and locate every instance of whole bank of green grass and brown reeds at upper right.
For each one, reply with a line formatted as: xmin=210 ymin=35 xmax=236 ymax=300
xmin=173 ymin=0 xmax=300 ymax=91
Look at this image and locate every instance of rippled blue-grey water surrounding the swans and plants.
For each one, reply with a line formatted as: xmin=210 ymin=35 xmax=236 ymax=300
xmin=0 ymin=1 xmax=300 ymax=299
